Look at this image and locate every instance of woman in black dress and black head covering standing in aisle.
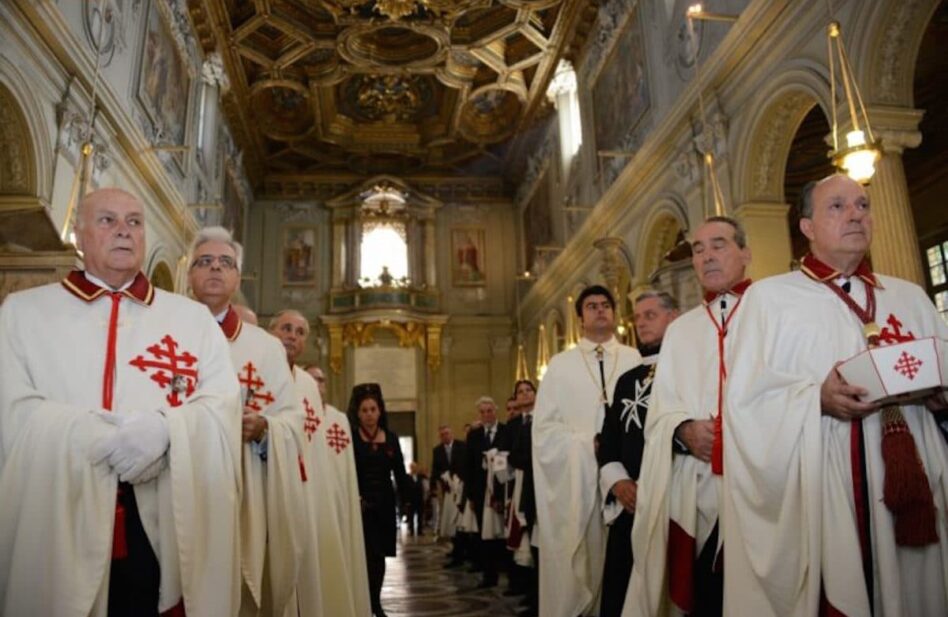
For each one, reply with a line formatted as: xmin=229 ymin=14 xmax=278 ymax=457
xmin=349 ymin=383 xmax=409 ymax=617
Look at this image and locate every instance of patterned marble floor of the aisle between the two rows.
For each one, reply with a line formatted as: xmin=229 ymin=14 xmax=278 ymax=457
xmin=382 ymin=529 xmax=520 ymax=617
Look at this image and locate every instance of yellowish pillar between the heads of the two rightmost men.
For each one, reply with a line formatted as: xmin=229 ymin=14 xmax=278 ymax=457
xmin=734 ymin=202 xmax=793 ymax=281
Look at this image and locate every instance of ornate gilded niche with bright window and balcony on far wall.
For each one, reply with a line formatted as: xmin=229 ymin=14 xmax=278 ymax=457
xmin=321 ymin=176 xmax=448 ymax=373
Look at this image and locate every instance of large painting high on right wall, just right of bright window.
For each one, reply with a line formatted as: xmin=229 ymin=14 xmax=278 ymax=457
xmin=592 ymin=5 xmax=651 ymax=156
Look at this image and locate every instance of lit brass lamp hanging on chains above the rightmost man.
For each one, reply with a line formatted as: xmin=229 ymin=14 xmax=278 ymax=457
xmin=826 ymin=21 xmax=881 ymax=184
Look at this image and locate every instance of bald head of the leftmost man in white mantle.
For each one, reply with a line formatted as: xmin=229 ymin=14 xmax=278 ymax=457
xmin=76 ymin=188 xmax=145 ymax=288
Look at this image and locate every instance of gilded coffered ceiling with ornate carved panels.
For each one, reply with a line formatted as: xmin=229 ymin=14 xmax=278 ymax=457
xmin=189 ymin=0 xmax=596 ymax=194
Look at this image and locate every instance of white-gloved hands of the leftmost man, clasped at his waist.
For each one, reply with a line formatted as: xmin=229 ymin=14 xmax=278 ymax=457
xmin=92 ymin=411 xmax=170 ymax=482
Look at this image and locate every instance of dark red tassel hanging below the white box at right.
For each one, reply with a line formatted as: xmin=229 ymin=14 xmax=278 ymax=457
xmin=882 ymin=414 xmax=938 ymax=546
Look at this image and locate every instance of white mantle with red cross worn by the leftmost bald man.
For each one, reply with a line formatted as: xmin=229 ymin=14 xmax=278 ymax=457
xmin=0 ymin=283 xmax=240 ymax=617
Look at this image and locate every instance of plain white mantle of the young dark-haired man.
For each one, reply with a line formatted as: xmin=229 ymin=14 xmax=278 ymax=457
xmin=532 ymin=338 xmax=642 ymax=617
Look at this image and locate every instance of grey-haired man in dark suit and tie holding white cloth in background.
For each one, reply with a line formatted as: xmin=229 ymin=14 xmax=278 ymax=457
xmin=464 ymin=396 xmax=509 ymax=588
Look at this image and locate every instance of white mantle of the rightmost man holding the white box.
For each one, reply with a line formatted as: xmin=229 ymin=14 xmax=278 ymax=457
xmin=721 ymin=272 xmax=948 ymax=617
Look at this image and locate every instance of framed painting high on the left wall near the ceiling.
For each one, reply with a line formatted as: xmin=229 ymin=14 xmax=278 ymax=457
xmin=135 ymin=0 xmax=192 ymax=174
